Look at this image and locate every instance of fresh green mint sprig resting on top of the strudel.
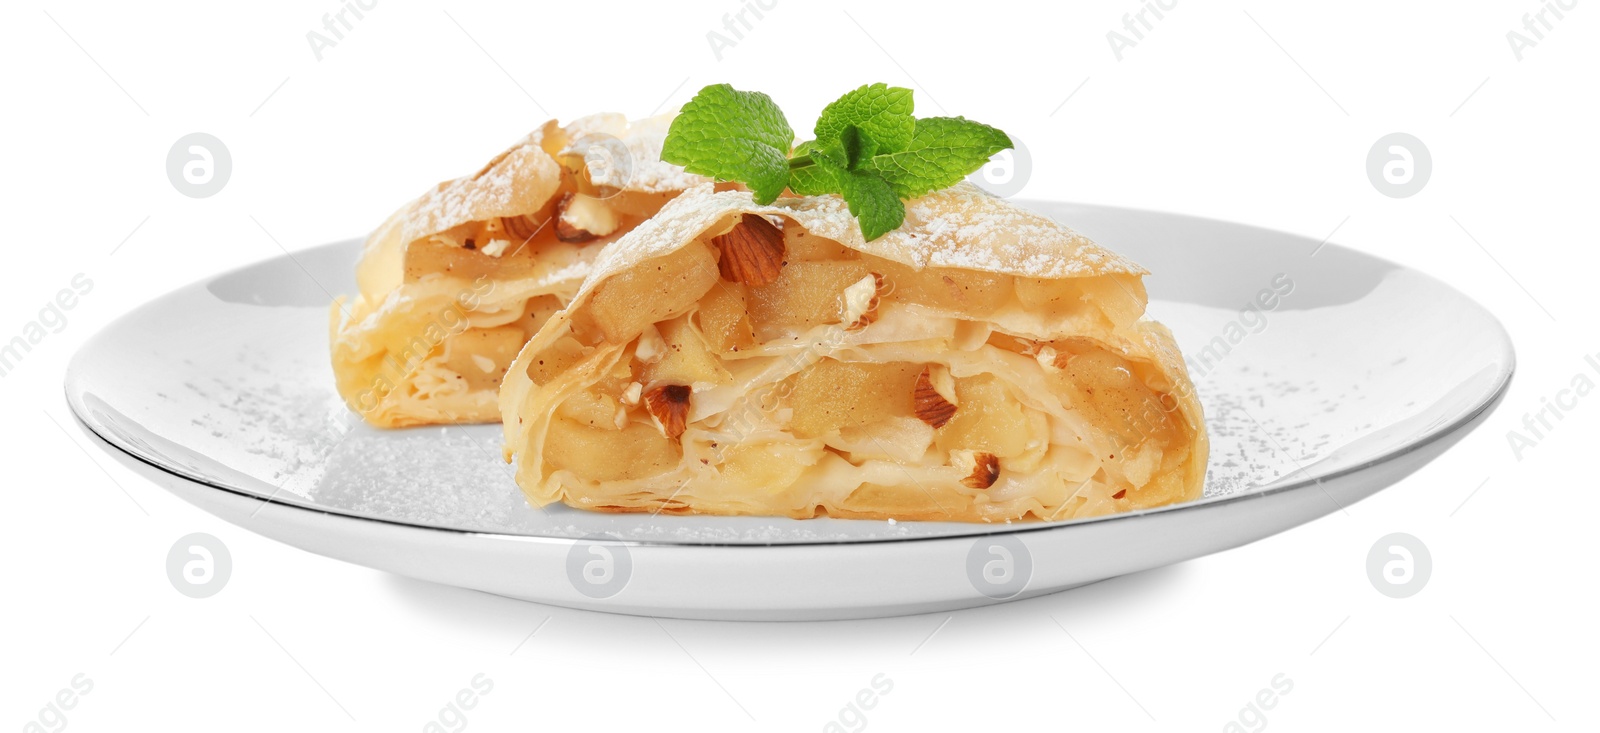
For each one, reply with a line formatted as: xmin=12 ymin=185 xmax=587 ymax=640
xmin=661 ymin=83 xmax=1011 ymax=242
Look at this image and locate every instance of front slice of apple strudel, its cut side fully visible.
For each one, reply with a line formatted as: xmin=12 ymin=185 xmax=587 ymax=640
xmin=501 ymin=184 xmax=1208 ymax=522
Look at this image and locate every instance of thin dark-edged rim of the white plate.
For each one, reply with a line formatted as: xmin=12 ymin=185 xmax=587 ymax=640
xmin=62 ymin=198 xmax=1517 ymax=549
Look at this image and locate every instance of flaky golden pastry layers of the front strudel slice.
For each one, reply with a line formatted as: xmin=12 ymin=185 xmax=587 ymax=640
xmin=499 ymin=184 xmax=1208 ymax=522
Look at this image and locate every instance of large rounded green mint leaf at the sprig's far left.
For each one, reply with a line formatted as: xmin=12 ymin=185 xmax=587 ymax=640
xmin=661 ymin=83 xmax=795 ymax=203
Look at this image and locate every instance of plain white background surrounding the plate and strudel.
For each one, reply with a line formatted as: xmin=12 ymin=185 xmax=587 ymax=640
xmin=0 ymin=0 xmax=1600 ymax=730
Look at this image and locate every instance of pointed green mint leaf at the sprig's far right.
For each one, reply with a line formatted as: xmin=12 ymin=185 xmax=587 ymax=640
xmin=861 ymin=117 xmax=1011 ymax=198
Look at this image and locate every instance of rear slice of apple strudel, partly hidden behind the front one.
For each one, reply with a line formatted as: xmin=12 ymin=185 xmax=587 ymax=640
xmin=330 ymin=114 xmax=706 ymax=427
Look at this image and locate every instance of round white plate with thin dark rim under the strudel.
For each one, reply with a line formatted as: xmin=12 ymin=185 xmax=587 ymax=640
xmin=66 ymin=202 xmax=1514 ymax=619
